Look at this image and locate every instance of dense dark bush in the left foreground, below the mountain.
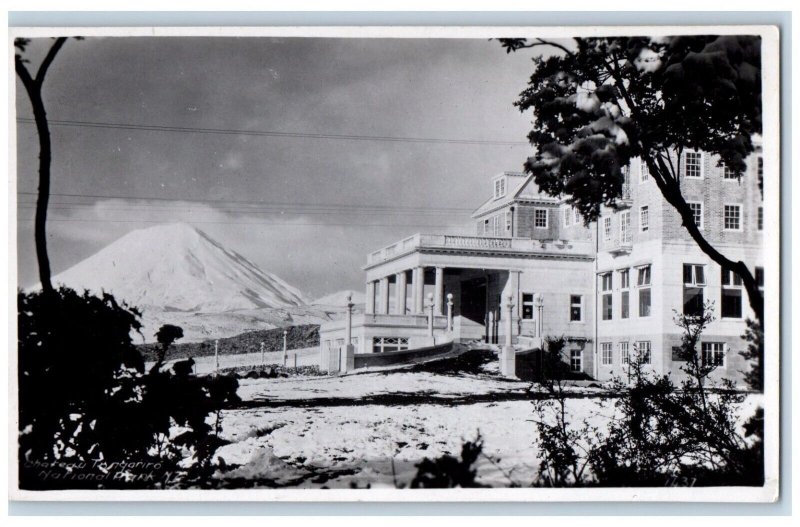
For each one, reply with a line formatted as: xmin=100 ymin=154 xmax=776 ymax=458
xmin=18 ymin=288 xmax=238 ymax=489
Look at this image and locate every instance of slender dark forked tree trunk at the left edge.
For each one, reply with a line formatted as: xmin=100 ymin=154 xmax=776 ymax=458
xmin=14 ymin=37 xmax=67 ymax=294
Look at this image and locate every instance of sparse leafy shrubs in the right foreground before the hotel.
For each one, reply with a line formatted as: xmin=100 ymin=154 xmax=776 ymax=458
xmin=534 ymin=305 xmax=764 ymax=487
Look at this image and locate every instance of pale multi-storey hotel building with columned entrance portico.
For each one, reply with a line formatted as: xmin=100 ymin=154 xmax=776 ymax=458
xmin=320 ymin=149 xmax=763 ymax=380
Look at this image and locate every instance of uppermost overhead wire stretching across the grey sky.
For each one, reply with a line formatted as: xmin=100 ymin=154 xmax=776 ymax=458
xmin=17 ymin=117 xmax=528 ymax=146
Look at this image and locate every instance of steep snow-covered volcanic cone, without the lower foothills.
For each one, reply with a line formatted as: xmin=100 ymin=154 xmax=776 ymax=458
xmin=53 ymin=223 xmax=306 ymax=312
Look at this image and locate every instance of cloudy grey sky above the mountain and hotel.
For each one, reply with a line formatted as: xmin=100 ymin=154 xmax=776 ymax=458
xmin=16 ymin=37 xmax=548 ymax=298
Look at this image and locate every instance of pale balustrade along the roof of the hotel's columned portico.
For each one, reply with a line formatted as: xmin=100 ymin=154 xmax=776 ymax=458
xmin=367 ymin=234 xmax=591 ymax=265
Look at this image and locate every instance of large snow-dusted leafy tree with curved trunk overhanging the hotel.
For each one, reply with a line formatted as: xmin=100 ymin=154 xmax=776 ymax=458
xmin=500 ymin=35 xmax=764 ymax=323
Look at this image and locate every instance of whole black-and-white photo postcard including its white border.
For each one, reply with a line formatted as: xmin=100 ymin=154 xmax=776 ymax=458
xmin=8 ymin=26 xmax=781 ymax=502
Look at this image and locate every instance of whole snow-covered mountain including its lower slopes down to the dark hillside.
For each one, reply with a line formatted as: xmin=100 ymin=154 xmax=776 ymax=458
xmin=46 ymin=223 xmax=338 ymax=342
